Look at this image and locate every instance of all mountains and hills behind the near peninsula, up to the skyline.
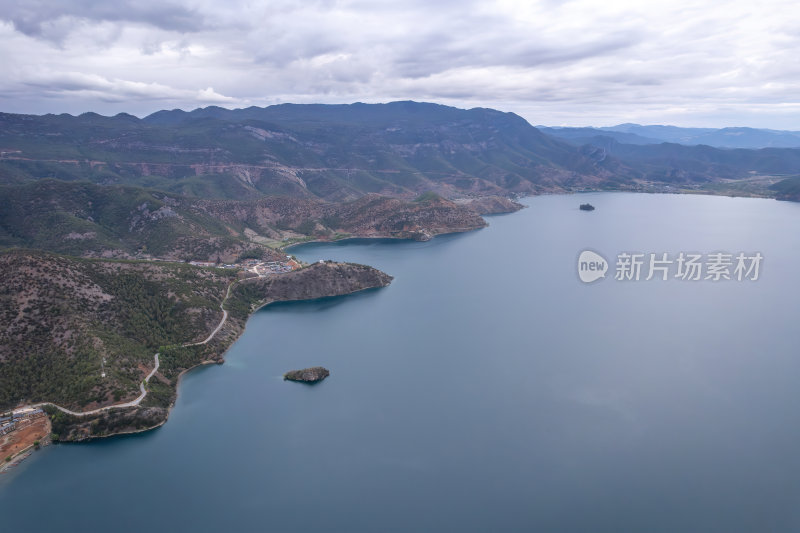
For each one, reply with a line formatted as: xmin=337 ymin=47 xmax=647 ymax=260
xmin=0 ymin=102 xmax=800 ymax=261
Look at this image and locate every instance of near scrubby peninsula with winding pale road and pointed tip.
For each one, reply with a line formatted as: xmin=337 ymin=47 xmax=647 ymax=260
xmin=0 ymin=251 xmax=392 ymax=441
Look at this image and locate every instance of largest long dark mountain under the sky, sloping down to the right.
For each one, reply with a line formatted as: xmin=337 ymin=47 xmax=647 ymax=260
xmin=0 ymin=102 xmax=635 ymax=202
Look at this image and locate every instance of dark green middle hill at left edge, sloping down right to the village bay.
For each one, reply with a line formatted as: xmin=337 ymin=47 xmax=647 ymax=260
xmin=0 ymin=179 xmax=284 ymax=262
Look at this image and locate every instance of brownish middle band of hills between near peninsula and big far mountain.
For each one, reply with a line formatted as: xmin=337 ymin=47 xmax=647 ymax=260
xmin=0 ymin=179 xmax=496 ymax=262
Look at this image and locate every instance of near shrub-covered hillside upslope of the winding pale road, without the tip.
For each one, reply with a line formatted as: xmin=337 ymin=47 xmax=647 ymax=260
xmin=0 ymin=251 xmax=236 ymax=410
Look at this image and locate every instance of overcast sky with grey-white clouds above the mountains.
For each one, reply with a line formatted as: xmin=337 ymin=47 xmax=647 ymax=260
xmin=0 ymin=0 xmax=800 ymax=130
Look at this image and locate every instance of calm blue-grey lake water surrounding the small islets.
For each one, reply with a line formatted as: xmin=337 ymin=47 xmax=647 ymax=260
xmin=0 ymin=194 xmax=800 ymax=533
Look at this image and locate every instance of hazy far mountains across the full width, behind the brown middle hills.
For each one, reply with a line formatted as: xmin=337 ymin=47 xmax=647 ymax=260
xmin=0 ymin=97 xmax=800 ymax=203
